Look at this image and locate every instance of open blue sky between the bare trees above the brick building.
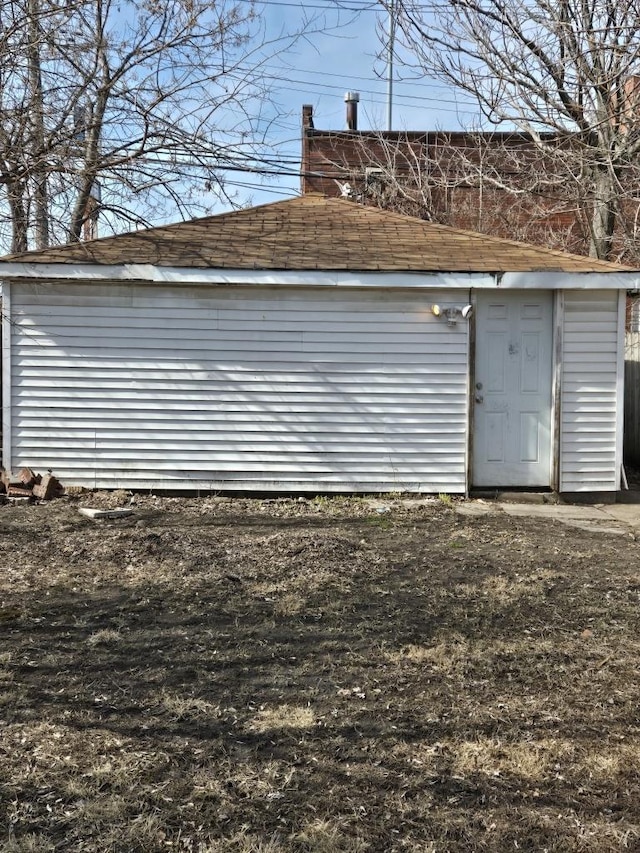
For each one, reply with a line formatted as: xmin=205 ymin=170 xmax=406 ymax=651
xmin=222 ymin=0 xmax=474 ymax=210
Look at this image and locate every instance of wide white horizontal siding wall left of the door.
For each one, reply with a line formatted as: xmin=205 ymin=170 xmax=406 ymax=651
xmin=11 ymin=283 xmax=468 ymax=493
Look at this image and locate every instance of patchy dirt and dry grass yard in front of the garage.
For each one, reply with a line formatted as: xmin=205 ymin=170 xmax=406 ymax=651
xmin=0 ymin=493 xmax=640 ymax=853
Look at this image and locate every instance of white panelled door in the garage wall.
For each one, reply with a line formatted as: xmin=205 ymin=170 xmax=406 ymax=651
xmin=473 ymin=290 xmax=553 ymax=487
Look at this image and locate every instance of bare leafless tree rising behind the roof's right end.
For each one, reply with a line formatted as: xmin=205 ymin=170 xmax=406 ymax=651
xmin=382 ymin=0 xmax=640 ymax=258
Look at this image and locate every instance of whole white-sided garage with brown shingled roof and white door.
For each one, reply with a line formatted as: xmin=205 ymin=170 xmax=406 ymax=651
xmin=0 ymin=195 xmax=640 ymax=494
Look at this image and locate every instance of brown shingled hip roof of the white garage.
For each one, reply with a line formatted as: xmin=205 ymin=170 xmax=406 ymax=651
xmin=2 ymin=195 xmax=625 ymax=272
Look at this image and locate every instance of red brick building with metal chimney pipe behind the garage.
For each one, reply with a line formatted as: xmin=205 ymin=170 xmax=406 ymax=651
xmin=301 ymin=93 xmax=640 ymax=264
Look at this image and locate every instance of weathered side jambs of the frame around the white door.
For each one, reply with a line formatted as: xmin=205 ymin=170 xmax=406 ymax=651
xmin=466 ymin=288 xmax=564 ymax=495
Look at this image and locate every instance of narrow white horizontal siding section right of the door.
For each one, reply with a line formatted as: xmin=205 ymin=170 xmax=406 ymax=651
xmin=560 ymin=291 xmax=621 ymax=492
